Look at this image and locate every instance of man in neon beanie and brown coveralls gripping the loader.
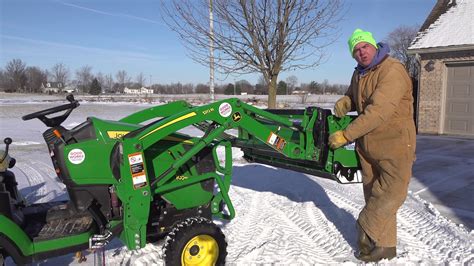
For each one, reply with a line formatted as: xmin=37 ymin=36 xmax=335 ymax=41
xmin=329 ymin=29 xmax=416 ymax=262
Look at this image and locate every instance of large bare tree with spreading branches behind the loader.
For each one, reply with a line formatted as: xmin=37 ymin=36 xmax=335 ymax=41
xmin=162 ymin=0 xmax=341 ymax=108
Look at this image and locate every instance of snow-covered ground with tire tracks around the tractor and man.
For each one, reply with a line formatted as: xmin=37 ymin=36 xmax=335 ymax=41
xmin=0 ymin=95 xmax=474 ymax=265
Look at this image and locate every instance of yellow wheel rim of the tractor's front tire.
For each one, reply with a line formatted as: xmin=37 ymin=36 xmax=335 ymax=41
xmin=181 ymin=235 xmax=219 ymax=265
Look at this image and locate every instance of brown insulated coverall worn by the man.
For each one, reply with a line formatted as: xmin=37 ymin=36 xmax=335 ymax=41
xmin=344 ymin=57 xmax=416 ymax=247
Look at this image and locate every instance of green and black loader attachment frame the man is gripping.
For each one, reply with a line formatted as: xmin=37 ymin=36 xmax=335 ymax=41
xmin=232 ymin=107 xmax=361 ymax=184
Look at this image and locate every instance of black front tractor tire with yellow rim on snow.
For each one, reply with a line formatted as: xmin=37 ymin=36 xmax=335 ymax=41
xmin=163 ymin=217 xmax=227 ymax=266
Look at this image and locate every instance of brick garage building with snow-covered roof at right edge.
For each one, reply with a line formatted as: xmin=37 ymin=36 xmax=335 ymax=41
xmin=408 ymin=0 xmax=474 ymax=136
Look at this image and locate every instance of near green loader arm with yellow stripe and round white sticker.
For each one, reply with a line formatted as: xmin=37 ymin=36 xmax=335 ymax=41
xmin=121 ymin=99 xmax=316 ymax=186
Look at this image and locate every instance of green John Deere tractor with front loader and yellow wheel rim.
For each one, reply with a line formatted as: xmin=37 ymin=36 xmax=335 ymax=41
xmin=0 ymin=95 xmax=360 ymax=265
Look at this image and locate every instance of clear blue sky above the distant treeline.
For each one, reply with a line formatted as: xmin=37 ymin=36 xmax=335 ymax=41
xmin=0 ymin=0 xmax=436 ymax=84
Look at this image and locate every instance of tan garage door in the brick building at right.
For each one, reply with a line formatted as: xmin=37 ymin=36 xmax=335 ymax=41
xmin=444 ymin=63 xmax=474 ymax=136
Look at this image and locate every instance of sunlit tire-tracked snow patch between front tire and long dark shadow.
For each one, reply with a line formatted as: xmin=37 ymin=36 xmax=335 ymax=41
xmin=226 ymin=187 xmax=352 ymax=263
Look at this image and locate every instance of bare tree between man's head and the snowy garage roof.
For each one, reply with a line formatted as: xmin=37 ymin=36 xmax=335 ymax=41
xmin=386 ymin=26 xmax=419 ymax=78
